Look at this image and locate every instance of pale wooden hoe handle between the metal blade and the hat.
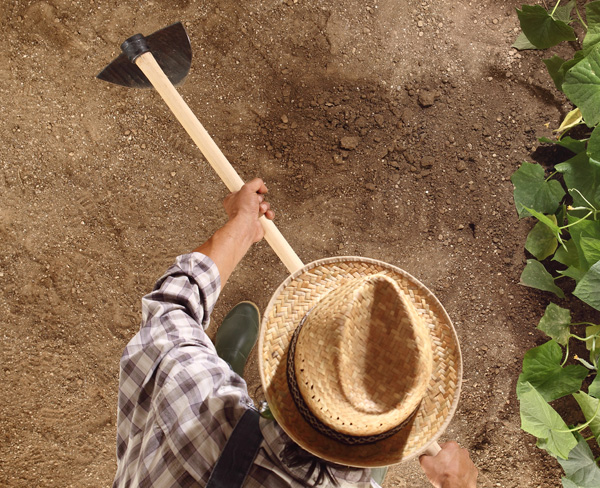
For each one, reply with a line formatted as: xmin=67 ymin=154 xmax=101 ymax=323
xmin=135 ymin=52 xmax=304 ymax=273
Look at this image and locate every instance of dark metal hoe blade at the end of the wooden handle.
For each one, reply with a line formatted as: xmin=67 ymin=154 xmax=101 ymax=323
xmin=97 ymin=22 xmax=192 ymax=88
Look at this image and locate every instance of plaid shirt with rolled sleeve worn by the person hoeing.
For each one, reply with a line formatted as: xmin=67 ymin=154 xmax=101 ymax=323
xmin=113 ymin=253 xmax=378 ymax=488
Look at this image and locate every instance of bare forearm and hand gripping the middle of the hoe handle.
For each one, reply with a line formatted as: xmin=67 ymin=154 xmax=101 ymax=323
xmin=194 ymin=178 xmax=275 ymax=288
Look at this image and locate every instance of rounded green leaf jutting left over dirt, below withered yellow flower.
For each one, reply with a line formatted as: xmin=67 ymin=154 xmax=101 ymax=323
xmin=510 ymin=162 xmax=565 ymax=217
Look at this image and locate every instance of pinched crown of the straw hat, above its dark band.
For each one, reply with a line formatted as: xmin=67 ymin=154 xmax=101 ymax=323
xmin=294 ymin=273 xmax=433 ymax=436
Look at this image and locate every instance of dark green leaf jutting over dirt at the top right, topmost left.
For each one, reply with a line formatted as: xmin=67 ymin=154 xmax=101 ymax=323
xmin=517 ymin=5 xmax=576 ymax=49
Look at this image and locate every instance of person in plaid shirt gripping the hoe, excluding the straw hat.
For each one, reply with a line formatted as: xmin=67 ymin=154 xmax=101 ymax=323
xmin=113 ymin=178 xmax=477 ymax=488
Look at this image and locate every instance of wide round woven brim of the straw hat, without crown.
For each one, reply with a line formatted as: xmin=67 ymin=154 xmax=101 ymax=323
xmin=258 ymin=256 xmax=462 ymax=468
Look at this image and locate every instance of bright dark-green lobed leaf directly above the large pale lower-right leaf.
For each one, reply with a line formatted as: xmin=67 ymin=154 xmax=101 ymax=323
xmin=517 ymin=340 xmax=589 ymax=402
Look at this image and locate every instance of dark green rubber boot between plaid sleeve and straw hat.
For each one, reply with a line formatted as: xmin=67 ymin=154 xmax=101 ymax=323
xmin=215 ymin=302 xmax=260 ymax=377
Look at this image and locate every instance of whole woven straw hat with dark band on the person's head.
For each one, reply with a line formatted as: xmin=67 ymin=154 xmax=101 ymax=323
xmin=258 ymin=257 xmax=462 ymax=467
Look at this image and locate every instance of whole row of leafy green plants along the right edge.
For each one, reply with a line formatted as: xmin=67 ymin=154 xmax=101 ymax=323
xmin=511 ymin=0 xmax=600 ymax=488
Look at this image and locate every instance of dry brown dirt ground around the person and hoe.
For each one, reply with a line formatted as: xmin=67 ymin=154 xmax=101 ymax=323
xmin=0 ymin=0 xmax=592 ymax=487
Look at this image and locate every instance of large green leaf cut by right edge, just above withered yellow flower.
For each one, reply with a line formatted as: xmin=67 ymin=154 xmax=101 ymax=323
xmin=562 ymin=46 xmax=600 ymax=127
